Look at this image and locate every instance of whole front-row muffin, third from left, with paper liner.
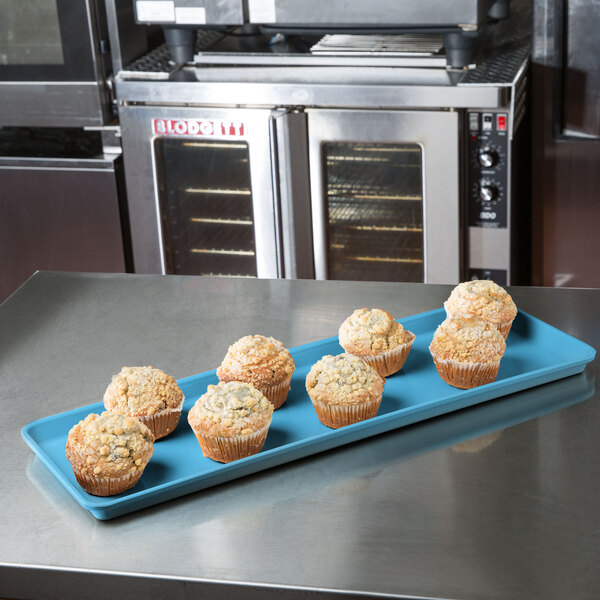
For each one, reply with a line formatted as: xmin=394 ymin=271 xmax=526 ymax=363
xmin=306 ymin=353 xmax=385 ymax=429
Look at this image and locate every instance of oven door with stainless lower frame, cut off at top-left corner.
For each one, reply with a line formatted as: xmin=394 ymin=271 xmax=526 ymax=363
xmin=0 ymin=0 xmax=110 ymax=127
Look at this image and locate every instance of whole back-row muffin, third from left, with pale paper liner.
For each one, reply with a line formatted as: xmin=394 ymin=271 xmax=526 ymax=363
xmin=339 ymin=308 xmax=415 ymax=377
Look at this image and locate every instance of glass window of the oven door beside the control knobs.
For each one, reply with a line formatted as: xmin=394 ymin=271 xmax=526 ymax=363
xmin=323 ymin=142 xmax=424 ymax=281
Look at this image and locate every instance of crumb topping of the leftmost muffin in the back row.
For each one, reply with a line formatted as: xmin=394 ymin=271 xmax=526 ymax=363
xmin=104 ymin=367 xmax=183 ymax=416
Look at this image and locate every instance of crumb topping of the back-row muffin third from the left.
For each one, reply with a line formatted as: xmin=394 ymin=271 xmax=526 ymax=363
xmin=339 ymin=308 xmax=411 ymax=356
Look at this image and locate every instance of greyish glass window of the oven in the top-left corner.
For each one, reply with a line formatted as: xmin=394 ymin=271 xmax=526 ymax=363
xmin=0 ymin=0 xmax=95 ymax=81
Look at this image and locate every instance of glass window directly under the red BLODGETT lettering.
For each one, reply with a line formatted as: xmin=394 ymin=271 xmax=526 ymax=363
xmin=155 ymin=138 xmax=257 ymax=277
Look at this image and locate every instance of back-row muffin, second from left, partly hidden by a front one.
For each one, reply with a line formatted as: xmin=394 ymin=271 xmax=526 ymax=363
xmin=217 ymin=335 xmax=296 ymax=409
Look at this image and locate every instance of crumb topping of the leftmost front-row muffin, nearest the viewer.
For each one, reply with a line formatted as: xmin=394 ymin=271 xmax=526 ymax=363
xmin=67 ymin=411 xmax=154 ymax=477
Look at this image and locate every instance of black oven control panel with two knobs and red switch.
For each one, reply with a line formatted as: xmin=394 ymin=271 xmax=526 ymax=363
xmin=467 ymin=112 xmax=508 ymax=229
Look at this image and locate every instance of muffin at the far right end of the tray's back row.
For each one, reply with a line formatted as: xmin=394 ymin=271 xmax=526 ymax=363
xmin=444 ymin=279 xmax=517 ymax=339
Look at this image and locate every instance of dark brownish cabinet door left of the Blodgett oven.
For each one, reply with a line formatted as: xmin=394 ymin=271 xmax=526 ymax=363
xmin=0 ymin=160 xmax=126 ymax=301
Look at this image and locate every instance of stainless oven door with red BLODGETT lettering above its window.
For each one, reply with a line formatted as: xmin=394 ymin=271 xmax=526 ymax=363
xmin=120 ymin=106 xmax=281 ymax=278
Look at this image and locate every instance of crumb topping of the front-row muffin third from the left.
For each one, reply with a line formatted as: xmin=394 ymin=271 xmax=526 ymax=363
xmin=306 ymin=353 xmax=385 ymax=404
